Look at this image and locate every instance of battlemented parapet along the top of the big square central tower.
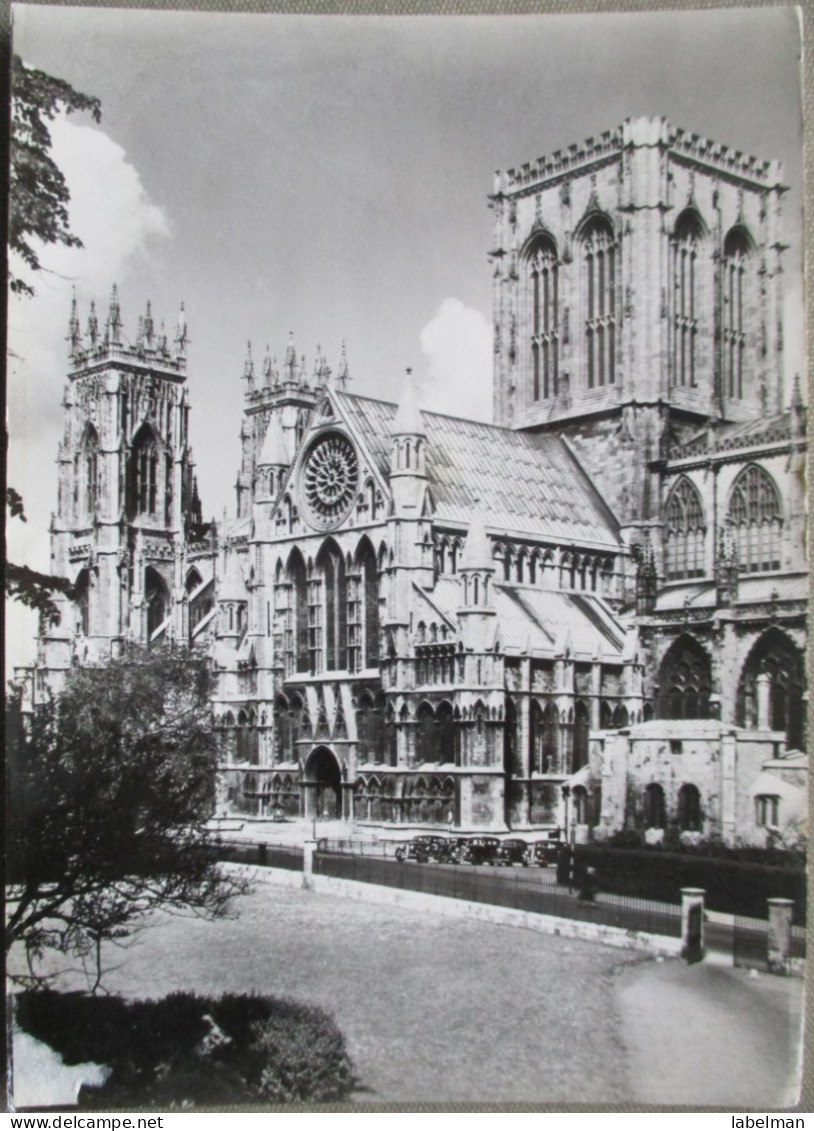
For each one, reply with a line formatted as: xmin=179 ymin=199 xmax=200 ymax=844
xmin=494 ymin=118 xmax=781 ymax=196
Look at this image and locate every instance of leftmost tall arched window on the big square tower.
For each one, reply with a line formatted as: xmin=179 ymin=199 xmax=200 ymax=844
xmin=526 ymin=236 xmax=560 ymax=400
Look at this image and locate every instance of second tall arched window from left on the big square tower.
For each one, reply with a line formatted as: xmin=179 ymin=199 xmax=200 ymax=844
xmin=582 ymin=216 xmax=616 ymax=389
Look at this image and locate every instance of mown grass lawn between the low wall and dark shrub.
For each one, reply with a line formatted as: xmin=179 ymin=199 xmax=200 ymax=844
xmin=17 ymin=877 xmax=631 ymax=1104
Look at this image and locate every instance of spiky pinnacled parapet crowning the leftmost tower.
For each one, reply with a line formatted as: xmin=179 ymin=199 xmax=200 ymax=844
xmin=67 ymin=284 xmax=189 ymax=379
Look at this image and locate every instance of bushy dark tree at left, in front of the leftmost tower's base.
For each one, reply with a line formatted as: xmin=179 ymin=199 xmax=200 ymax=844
xmin=6 ymin=648 xmax=246 ymax=983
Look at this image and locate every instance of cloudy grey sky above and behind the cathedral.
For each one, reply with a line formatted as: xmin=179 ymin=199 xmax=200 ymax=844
xmin=9 ymin=6 xmax=802 ymax=659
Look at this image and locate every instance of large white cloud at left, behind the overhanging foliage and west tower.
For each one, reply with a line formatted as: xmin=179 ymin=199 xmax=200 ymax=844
xmin=7 ymin=118 xmax=171 ymax=664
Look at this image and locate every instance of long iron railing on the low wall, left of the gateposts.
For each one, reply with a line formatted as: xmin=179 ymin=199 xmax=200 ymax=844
xmin=314 ymin=852 xmax=681 ymax=938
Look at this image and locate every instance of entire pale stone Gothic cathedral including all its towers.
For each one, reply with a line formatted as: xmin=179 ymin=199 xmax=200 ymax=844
xmin=41 ymin=119 xmax=807 ymax=843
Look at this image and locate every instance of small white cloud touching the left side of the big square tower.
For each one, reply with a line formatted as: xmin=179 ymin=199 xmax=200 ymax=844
xmin=421 ymin=299 xmax=492 ymax=421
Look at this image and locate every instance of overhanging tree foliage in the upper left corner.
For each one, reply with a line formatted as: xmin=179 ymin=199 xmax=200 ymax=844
xmin=9 ymin=55 xmax=102 ymax=295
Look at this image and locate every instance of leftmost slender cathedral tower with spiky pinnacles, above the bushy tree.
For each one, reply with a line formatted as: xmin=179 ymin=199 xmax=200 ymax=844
xmin=40 ymin=286 xmax=200 ymax=687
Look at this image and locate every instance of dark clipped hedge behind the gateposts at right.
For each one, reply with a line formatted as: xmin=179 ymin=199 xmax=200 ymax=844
xmin=574 ymin=845 xmax=806 ymax=924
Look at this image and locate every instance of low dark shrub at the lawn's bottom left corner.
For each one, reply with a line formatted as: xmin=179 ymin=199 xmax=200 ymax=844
xmin=17 ymin=991 xmax=355 ymax=1110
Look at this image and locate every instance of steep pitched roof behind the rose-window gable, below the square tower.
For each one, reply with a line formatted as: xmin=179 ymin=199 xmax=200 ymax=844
xmin=335 ymin=391 xmax=620 ymax=546
